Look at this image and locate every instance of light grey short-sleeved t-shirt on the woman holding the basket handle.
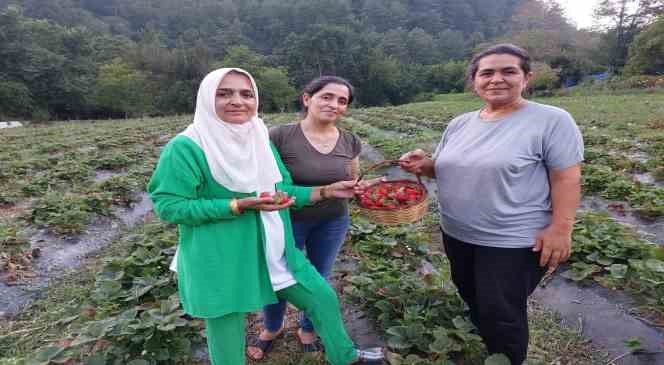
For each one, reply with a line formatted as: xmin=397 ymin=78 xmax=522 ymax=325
xmin=433 ymin=101 xmax=583 ymax=248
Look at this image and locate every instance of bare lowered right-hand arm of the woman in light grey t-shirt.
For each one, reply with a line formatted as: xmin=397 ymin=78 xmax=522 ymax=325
xmin=533 ymin=164 xmax=581 ymax=269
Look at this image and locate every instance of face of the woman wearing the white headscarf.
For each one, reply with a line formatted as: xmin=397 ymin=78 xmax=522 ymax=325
xmin=214 ymin=73 xmax=258 ymax=124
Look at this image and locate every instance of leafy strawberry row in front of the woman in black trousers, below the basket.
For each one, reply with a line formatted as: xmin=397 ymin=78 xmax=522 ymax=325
xmin=344 ymin=216 xmax=484 ymax=363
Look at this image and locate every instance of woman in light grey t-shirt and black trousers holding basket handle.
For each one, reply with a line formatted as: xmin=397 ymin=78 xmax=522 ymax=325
xmin=401 ymin=44 xmax=583 ymax=365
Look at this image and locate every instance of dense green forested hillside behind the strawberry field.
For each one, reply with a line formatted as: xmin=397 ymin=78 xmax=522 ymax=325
xmin=0 ymin=0 xmax=664 ymax=121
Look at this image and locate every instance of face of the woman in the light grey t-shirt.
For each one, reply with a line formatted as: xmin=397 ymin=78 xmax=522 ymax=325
xmin=473 ymin=54 xmax=532 ymax=106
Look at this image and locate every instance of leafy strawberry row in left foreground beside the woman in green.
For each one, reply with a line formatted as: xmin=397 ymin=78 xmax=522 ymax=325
xmin=28 ymin=222 xmax=203 ymax=364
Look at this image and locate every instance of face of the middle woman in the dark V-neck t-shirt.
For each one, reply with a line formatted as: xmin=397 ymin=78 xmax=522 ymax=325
xmin=302 ymin=83 xmax=350 ymax=122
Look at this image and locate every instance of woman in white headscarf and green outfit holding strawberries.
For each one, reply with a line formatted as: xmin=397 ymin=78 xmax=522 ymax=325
xmin=148 ymin=68 xmax=382 ymax=365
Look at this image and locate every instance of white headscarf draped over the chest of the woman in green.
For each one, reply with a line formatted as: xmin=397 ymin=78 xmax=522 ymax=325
xmin=180 ymin=68 xmax=282 ymax=193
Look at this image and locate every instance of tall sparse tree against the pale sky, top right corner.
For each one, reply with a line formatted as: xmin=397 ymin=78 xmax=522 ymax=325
xmin=595 ymin=0 xmax=664 ymax=70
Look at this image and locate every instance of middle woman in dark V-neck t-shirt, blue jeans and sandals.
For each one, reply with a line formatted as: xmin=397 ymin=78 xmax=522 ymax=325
xmin=248 ymin=76 xmax=361 ymax=360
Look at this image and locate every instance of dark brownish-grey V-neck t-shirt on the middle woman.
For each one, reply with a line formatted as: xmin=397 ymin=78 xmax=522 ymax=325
xmin=270 ymin=123 xmax=362 ymax=221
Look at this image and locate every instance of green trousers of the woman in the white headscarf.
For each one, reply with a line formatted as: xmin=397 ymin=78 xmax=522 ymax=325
xmin=205 ymin=277 xmax=357 ymax=365
